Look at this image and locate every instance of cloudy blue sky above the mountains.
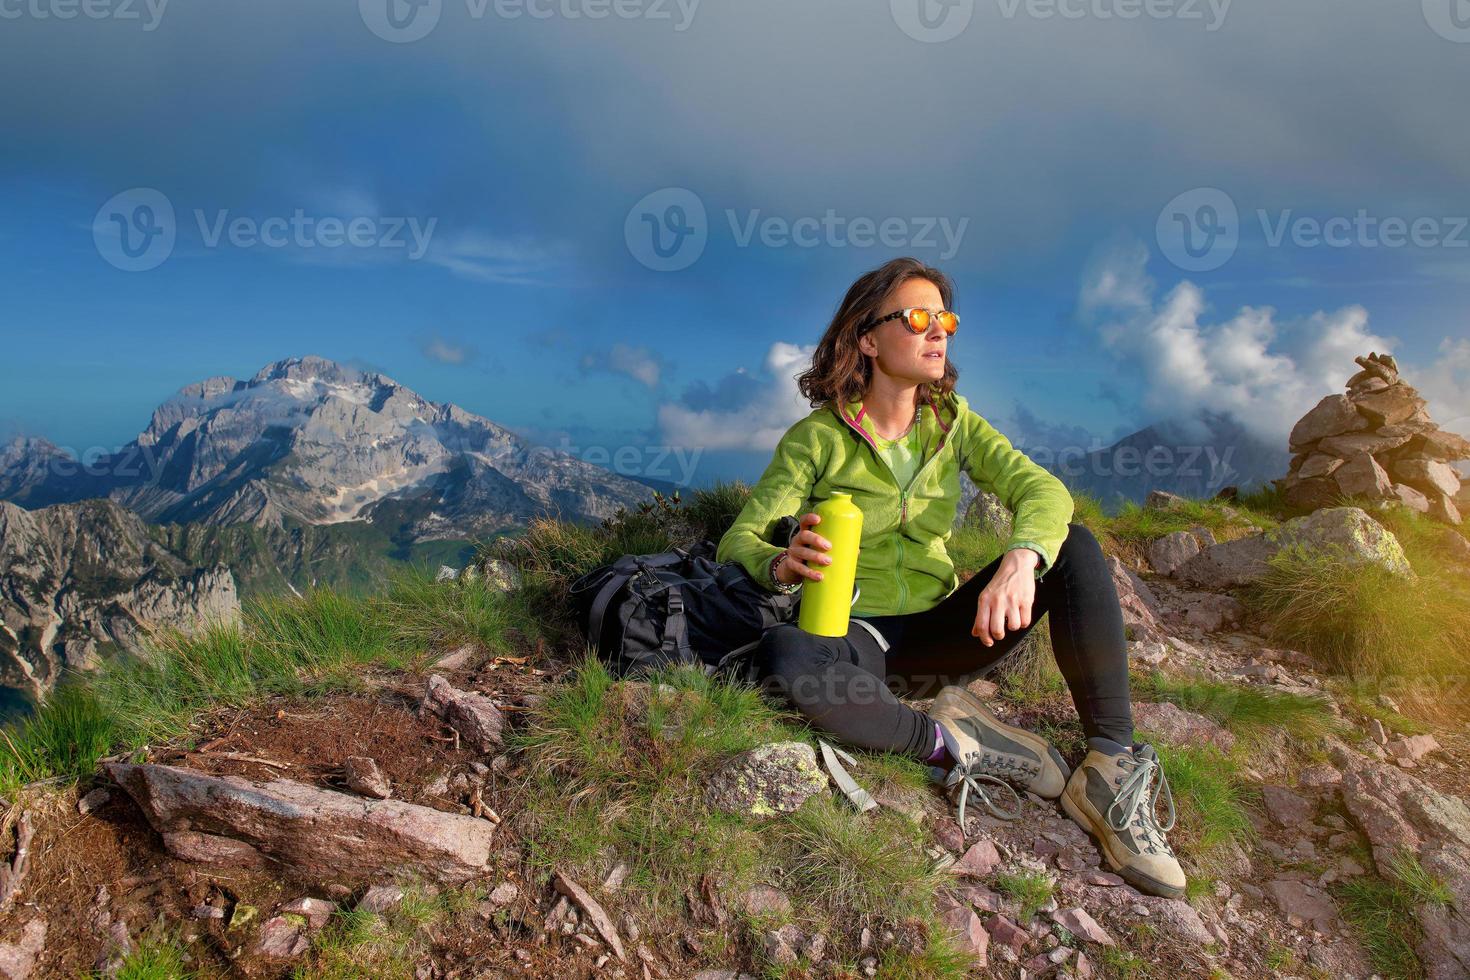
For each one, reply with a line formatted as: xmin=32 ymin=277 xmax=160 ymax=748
xmin=0 ymin=0 xmax=1470 ymax=483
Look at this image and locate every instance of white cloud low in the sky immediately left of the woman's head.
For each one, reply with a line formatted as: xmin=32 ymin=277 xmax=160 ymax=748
xmin=659 ymin=341 xmax=817 ymax=451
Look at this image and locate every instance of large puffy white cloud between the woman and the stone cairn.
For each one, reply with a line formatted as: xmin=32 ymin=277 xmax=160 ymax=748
xmin=1080 ymin=241 xmax=1414 ymax=442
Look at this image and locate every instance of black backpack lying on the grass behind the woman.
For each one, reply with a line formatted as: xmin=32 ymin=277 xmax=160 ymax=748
xmin=570 ymin=517 xmax=801 ymax=683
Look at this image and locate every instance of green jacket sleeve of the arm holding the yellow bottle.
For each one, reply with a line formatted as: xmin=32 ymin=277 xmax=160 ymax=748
xmin=714 ymin=423 xmax=817 ymax=591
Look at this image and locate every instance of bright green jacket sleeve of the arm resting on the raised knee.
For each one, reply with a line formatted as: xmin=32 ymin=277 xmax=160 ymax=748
xmin=960 ymin=408 xmax=1073 ymax=577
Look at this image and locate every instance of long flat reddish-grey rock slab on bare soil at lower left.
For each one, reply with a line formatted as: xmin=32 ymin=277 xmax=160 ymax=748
xmin=106 ymin=763 xmax=494 ymax=882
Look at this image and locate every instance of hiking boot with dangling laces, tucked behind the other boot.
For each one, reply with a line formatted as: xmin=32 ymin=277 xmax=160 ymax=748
xmin=929 ymin=685 xmax=1070 ymax=829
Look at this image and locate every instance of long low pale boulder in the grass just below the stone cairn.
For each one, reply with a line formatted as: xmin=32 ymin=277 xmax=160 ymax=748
xmin=1177 ymin=507 xmax=1414 ymax=589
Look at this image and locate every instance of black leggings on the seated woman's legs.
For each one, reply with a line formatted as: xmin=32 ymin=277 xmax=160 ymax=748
xmin=757 ymin=523 xmax=1133 ymax=755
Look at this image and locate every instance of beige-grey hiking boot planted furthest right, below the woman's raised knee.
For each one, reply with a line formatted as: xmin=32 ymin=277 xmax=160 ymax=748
xmin=1061 ymin=738 xmax=1185 ymax=898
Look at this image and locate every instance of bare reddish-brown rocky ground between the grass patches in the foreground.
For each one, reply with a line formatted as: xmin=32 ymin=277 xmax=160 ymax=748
xmin=0 ymin=511 xmax=1470 ymax=980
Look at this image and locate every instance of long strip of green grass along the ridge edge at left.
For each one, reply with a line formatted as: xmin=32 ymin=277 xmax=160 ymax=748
xmin=0 ymin=570 xmax=537 ymax=795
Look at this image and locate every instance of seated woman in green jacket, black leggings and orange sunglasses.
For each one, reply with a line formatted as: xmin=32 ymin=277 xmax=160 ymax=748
xmin=717 ymin=259 xmax=1185 ymax=896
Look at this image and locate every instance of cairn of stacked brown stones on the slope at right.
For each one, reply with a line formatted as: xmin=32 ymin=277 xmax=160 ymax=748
xmin=1272 ymin=353 xmax=1470 ymax=525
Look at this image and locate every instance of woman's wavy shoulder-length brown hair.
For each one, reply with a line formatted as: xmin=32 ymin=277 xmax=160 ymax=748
xmin=797 ymin=257 xmax=960 ymax=408
